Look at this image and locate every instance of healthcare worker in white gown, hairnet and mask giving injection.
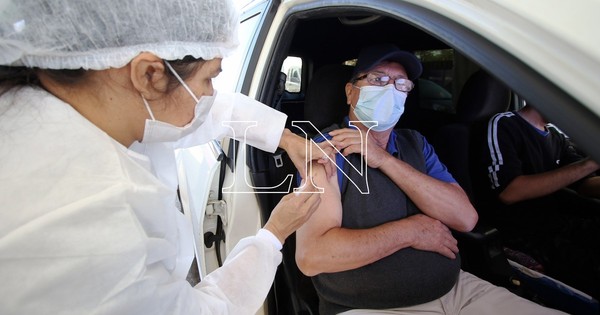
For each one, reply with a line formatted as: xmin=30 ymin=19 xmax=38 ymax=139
xmin=0 ymin=0 xmax=328 ymax=315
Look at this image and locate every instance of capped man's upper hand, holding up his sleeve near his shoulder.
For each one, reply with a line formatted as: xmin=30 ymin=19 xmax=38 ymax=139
xmin=329 ymin=128 xmax=392 ymax=168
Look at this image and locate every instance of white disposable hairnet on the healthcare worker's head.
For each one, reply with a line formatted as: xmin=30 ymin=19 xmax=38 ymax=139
xmin=0 ymin=0 xmax=239 ymax=70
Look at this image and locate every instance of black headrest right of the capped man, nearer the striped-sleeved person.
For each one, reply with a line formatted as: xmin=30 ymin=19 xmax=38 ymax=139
xmin=456 ymin=70 xmax=510 ymax=122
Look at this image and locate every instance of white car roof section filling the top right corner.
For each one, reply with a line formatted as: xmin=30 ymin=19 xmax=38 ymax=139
xmin=420 ymin=0 xmax=600 ymax=115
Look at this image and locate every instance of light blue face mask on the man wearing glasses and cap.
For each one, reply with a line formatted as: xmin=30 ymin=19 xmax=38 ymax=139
xmin=354 ymin=84 xmax=407 ymax=131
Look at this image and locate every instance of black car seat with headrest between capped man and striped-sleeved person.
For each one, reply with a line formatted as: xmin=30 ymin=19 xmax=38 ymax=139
xmin=430 ymin=70 xmax=516 ymax=290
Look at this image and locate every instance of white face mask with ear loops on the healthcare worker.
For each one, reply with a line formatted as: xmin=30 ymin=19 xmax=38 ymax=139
xmin=141 ymin=61 xmax=217 ymax=143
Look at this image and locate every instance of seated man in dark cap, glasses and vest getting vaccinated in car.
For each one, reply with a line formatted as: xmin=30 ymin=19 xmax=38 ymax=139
xmin=296 ymin=44 xmax=560 ymax=315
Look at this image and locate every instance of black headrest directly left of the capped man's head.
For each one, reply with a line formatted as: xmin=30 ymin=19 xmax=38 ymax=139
xmin=304 ymin=64 xmax=354 ymax=130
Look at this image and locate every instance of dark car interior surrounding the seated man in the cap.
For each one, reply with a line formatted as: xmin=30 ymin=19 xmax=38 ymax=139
xmin=237 ymin=9 xmax=598 ymax=314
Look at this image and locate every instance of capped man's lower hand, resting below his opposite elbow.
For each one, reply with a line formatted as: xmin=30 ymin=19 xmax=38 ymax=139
xmin=403 ymin=214 xmax=458 ymax=259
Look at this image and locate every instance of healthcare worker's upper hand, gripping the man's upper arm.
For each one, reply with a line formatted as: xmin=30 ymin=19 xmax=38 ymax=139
xmin=279 ymin=129 xmax=335 ymax=178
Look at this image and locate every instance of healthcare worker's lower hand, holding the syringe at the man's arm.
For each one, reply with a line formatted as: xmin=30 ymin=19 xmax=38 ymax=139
xmin=264 ymin=181 xmax=321 ymax=244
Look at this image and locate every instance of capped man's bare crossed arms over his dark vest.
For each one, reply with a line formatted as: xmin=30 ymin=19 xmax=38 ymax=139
xmin=296 ymin=128 xmax=477 ymax=276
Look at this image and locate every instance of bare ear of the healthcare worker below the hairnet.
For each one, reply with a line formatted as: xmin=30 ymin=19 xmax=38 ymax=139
xmin=129 ymin=53 xmax=169 ymax=100
